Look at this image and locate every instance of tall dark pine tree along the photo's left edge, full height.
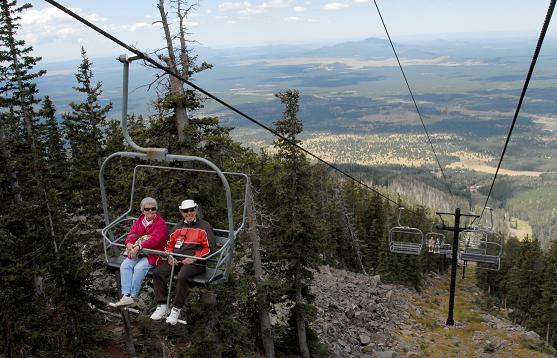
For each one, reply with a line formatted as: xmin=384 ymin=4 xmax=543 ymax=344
xmin=0 ymin=0 xmax=50 ymax=356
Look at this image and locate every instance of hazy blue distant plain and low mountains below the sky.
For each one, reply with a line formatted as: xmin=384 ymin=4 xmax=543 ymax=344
xmin=37 ymin=37 xmax=557 ymax=124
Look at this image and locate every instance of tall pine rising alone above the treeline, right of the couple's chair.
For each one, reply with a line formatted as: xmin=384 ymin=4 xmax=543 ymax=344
xmin=264 ymin=90 xmax=319 ymax=358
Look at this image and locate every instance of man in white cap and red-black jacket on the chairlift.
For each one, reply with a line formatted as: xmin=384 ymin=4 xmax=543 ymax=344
xmin=151 ymin=199 xmax=215 ymax=325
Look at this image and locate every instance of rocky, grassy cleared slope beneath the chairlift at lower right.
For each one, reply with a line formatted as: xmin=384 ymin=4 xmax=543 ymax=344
xmin=313 ymin=266 xmax=554 ymax=358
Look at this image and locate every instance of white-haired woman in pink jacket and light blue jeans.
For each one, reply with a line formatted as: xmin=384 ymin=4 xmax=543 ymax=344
xmin=110 ymin=197 xmax=168 ymax=307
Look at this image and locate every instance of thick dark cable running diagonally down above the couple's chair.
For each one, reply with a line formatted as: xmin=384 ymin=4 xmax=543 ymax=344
xmin=44 ymin=0 xmax=417 ymax=215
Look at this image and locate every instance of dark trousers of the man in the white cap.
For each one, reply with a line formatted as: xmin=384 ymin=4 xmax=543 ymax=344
xmin=153 ymin=262 xmax=205 ymax=308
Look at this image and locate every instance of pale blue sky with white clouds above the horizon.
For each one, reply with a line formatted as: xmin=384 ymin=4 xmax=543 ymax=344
xmin=20 ymin=0 xmax=557 ymax=61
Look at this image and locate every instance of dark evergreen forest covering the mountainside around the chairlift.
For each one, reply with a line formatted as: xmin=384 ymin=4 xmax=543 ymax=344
xmin=0 ymin=0 xmax=557 ymax=357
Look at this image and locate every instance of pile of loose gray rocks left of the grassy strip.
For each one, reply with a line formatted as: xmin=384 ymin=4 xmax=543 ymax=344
xmin=312 ymin=267 xmax=408 ymax=358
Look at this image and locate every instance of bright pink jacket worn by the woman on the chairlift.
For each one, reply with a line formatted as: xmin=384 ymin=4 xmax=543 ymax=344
xmin=125 ymin=213 xmax=168 ymax=266
